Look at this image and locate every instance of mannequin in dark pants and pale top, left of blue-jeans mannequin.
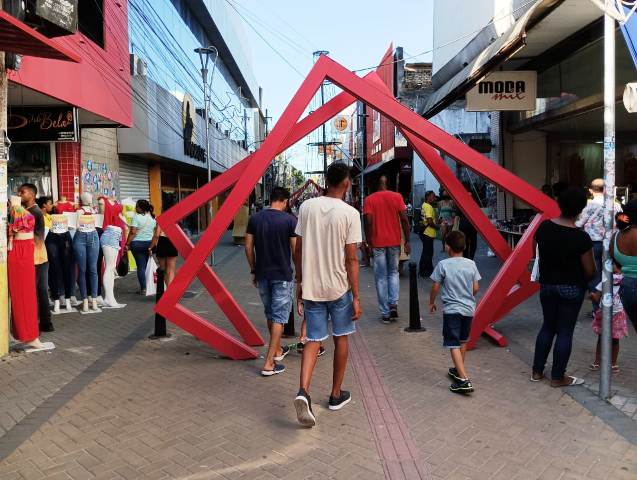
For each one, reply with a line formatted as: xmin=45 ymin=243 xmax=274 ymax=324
xmin=45 ymin=214 xmax=75 ymax=315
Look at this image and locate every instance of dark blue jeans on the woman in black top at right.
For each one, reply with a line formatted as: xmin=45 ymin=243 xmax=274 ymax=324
xmin=533 ymin=285 xmax=585 ymax=380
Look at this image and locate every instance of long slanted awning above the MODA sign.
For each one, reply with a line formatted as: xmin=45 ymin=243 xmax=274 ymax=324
xmin=422 ymin=0 xmax=601 ymax=118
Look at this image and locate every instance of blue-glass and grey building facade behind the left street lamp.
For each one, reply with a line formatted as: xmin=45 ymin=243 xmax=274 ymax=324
xmin=118 ymin=0 xmax=265 ymax=233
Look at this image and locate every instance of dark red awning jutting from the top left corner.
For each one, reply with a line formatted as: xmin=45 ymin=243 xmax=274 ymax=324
xmin=0 ymin=11 xmax=82 ymax=63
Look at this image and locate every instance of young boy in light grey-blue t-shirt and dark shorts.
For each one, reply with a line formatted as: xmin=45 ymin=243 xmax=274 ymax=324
xmin=429 ymin=231 xmax=481 ymax=393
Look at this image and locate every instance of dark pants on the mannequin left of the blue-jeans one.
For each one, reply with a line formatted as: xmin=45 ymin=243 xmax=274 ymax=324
xmin=45 ymin=232 xmax=75 ymax=300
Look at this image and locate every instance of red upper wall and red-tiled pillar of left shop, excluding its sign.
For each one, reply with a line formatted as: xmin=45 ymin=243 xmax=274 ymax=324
xmin=8 ymin=0 xmax=132 ymax=200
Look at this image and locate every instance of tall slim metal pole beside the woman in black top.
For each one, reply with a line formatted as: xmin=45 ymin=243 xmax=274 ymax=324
xmin=599 ymin=0 xmax=616 ymax=400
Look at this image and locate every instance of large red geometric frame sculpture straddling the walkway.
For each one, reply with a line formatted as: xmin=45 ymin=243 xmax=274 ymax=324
xmin=155 ymin=56 xmax=559 ymax=359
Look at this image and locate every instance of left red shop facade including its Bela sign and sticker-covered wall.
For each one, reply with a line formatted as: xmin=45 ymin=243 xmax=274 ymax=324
xmin=7 ymin=0 xmax=132 ymax=201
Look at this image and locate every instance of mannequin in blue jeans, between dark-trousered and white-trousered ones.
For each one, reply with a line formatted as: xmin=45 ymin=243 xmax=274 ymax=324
xmin=73 ymin=192 xmax=101 ymax=314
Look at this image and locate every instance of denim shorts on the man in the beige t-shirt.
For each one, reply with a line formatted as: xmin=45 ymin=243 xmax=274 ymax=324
xmin=303 ymin=291 xmax=356 ymax=342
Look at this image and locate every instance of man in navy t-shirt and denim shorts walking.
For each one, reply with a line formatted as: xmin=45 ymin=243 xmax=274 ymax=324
xmin=245 ymin=187 xmax=296 ymax=377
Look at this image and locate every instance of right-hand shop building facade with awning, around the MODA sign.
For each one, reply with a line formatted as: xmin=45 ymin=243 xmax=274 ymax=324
xmin=421 ymin=0 xmax=637 ymax=224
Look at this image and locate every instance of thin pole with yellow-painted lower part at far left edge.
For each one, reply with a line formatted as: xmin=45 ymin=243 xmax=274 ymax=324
xmin=0 ymin=0 xmax=9 ymax=357
